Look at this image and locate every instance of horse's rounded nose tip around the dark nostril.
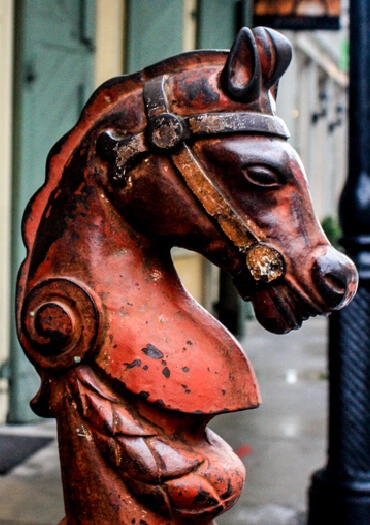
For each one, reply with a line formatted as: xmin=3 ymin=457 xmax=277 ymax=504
xmin=312 ymin=246 xmax=358 ymax=311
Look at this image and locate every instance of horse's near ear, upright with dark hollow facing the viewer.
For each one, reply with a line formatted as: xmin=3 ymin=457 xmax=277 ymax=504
xmin=221 ymin=27 xmax=261 ymax=102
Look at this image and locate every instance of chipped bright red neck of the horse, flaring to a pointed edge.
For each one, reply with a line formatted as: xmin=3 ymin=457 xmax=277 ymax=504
xmin=31 ymin=188 xmax=259 ymax=414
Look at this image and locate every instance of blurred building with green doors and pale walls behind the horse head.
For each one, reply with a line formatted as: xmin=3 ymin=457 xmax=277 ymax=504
xmin=0 ymin=0 xmax=348 ymax=423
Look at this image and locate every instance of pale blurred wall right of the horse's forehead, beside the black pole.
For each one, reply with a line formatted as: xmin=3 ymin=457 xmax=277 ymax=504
xmin=277 ymin=31 xmax=348 ymax=220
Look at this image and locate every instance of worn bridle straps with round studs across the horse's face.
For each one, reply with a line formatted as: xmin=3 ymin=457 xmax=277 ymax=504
xmin=143 ymin=76 xmax=289 ymax=283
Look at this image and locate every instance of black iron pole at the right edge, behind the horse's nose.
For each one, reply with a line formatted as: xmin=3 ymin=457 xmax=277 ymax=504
xmin=308 ymin=0 xmax=370 ymax=525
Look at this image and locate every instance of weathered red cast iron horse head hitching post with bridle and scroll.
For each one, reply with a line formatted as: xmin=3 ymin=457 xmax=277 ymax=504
xmin=17 ymin=28 xmax=356 ymax=525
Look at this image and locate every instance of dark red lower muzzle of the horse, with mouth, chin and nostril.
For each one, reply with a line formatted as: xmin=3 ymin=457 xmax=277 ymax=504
xmin=234 ymin=245 xmax=358 ymax=334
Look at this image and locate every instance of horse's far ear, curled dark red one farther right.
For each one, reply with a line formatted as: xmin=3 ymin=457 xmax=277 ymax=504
xmin=253 ymin=27 xmax=292 ymax=89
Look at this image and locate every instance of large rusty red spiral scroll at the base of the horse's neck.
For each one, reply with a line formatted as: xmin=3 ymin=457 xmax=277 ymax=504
xmin=20 ymin=278 xmax=100 ymax=370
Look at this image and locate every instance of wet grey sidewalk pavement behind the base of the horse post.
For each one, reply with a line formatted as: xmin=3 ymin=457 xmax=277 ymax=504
xmin=0 ymin=318 xmax=327 ymax=525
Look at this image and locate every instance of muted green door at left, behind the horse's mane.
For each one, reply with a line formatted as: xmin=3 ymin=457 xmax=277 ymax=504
xmin=8 ymin=0 xmax=95 ymax=423
